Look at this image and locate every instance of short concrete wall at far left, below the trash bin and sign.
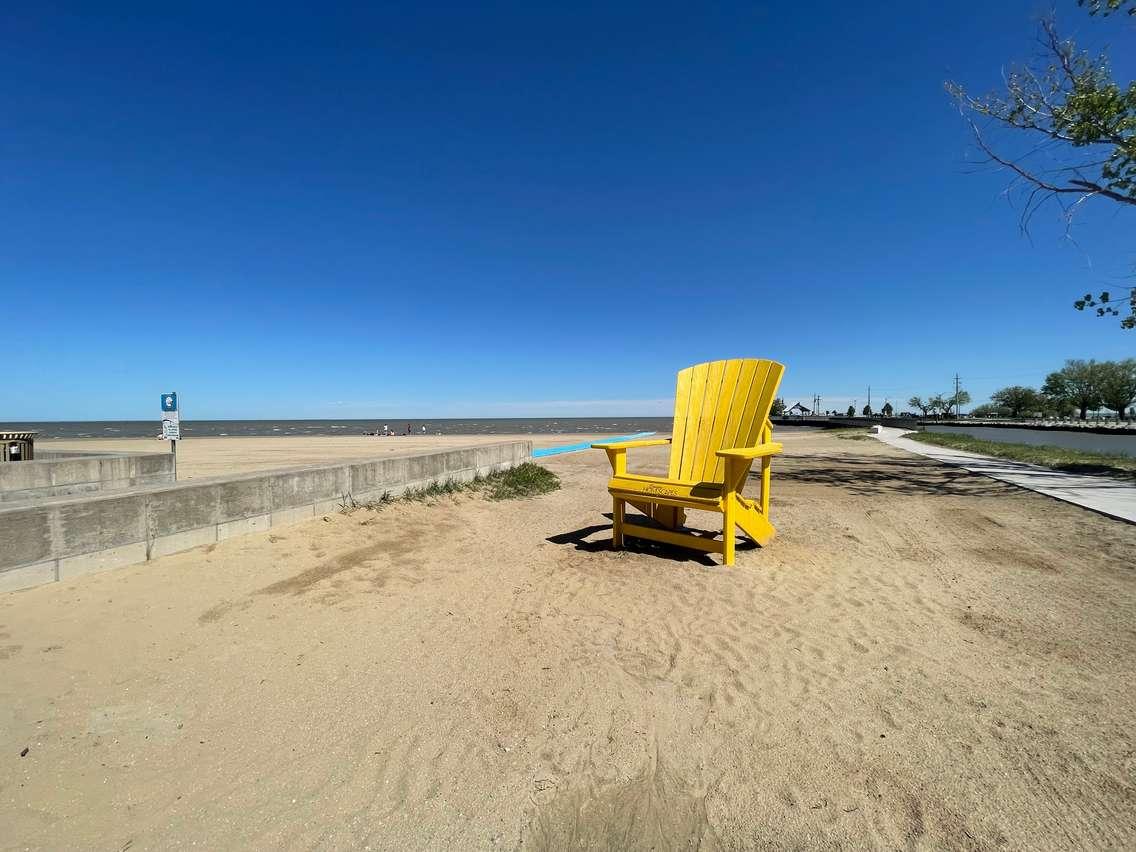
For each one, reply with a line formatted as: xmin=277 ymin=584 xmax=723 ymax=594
xmin=0 ymin=452 xmax=174 ymax=503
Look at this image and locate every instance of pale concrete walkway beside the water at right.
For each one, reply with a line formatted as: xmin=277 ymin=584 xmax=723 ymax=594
xmin=878 ymin=426 xmax=1136 ymax=524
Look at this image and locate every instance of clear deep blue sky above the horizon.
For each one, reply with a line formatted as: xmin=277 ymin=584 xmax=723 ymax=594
xmin=0 ymin=0 xmax=1136 ymax=421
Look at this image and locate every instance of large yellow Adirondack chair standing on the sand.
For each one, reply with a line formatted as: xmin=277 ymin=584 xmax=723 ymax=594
xmin=592 ymin=358 xmax=785 ymax=565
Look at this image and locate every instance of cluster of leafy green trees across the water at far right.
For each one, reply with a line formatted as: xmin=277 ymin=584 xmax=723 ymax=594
xmin=970 ymin=358 xmax=1136 ymax=420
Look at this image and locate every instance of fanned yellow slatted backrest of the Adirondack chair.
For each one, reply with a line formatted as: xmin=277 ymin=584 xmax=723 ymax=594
xmin=668 ymin=358 xmax=785 ymax=482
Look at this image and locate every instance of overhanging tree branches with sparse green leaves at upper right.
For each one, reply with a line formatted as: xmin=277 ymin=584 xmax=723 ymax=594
xmin=946 ymin=0 xmax=1136 ymax=328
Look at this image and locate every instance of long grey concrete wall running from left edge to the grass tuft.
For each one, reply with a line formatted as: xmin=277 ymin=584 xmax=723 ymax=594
xmin=0 ymin=441 xmax=533 ymax=592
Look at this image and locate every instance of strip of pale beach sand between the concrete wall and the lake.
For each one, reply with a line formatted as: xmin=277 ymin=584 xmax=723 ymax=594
xmin=35 ymin=433 xmax=607 ymax=481
